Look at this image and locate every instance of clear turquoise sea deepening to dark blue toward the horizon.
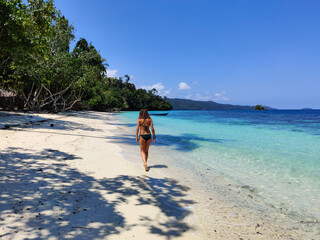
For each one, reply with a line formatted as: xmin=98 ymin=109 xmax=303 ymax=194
xmin=118 ymin=110 xmax=320 ymax=218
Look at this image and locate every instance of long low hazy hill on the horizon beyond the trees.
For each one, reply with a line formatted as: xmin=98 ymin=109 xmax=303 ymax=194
xmin=167 ymin=98 xmax=254 ymax=110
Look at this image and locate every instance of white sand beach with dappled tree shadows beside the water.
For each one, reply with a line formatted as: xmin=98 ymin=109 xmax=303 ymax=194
xmin=0 ymin=112 xmax=316 ymax=240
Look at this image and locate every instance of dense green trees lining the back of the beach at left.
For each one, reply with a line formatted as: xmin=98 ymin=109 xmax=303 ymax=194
xmin=0 ymin=0 xmax=172 ymax=111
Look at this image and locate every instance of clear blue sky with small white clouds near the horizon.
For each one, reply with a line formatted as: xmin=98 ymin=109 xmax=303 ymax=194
xmin=55 ymin=0 xmax=320 ymax=109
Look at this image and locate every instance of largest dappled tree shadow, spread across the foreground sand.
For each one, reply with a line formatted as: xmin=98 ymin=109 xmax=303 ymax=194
xmin=0 ymin=148 xmax=194 ymax=239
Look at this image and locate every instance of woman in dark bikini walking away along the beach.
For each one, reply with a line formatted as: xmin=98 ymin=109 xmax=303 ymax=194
xmin=136 ymin=109 xmax=156 ymax=172
